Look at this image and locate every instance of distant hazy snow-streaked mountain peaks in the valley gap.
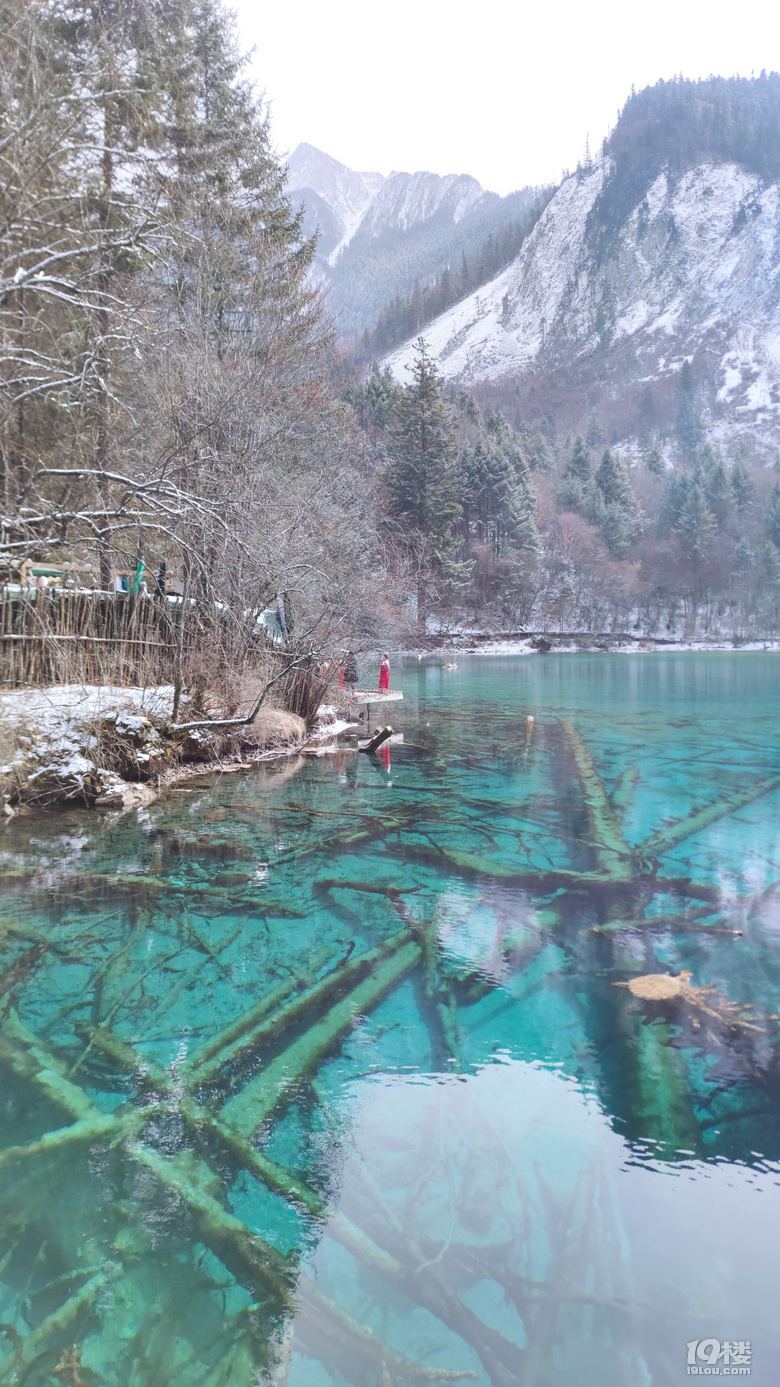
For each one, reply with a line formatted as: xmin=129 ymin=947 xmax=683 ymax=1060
xmin=287 ymin=144 xmax=539 ymax=336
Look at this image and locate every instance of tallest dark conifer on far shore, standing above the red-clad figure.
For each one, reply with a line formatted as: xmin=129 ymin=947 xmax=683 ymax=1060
xmin=387 ymin=337 xmax=468 ymax=637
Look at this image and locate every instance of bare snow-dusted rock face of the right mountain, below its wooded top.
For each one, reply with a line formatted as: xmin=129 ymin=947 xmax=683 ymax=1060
xmin=386 ymin=158 xmax=780 ymax=452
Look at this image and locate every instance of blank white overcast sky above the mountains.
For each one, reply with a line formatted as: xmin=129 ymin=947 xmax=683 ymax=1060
xmin=235 ymin=0 xmax=780 ymax=193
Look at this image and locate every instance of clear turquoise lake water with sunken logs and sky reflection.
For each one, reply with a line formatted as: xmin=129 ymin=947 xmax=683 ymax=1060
xmin=0 ymin=653 xmax=780 ymax=1387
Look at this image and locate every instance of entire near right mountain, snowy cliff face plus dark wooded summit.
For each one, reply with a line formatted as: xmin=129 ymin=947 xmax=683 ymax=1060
xmin=382 ymin=74 xmax=780 ymax=459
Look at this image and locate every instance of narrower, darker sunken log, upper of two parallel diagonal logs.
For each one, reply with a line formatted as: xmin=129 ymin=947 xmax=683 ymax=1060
xmin=189 ymin=929 xmax=409 ymax=1085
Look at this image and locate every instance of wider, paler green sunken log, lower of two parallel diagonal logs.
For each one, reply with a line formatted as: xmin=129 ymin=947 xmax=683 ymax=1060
xmin=219 ymin=931 xmax=421 ymax=1136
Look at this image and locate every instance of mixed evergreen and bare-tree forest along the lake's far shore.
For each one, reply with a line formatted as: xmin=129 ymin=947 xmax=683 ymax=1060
xmin=347 ymin=341 xmax=780 ymax=642
